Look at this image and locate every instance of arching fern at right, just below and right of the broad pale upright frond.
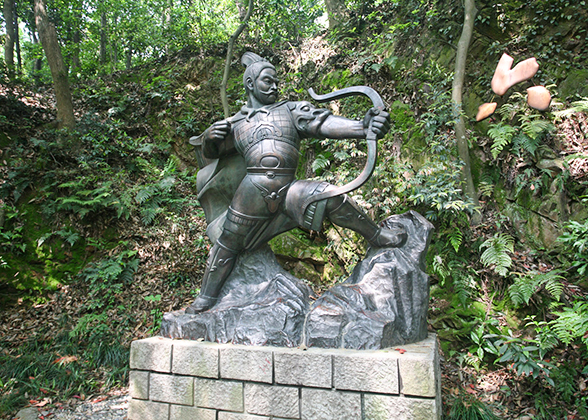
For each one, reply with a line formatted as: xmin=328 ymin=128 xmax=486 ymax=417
xmin=508 ymin=270 xmax=563 ymax=306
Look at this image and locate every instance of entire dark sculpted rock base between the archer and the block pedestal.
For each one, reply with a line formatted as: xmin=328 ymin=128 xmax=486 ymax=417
xmin=161 ymin=211 xmax=433 ymax=350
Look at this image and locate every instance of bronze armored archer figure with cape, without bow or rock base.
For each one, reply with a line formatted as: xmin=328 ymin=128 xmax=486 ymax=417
xmin=186 ymin=52 xmax=406 ymax=314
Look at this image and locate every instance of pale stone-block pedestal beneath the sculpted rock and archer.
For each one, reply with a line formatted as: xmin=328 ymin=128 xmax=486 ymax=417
xmin=128 ymin=334 xmax=441 ymax=420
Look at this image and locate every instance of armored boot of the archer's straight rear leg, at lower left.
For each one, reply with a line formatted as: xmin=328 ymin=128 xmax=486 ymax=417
xmin=186 ymin=241 xmax=238 ymax=314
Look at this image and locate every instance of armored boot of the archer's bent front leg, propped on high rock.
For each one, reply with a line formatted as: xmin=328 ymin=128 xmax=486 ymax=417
xmin=327 ymin=196 xmax=407 ymax=248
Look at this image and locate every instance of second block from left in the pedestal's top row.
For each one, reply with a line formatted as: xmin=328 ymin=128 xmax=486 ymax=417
xmin=172 ymin=340 xmax=219 ymax=378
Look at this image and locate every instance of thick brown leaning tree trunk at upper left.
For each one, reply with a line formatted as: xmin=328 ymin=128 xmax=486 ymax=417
xmin=35 ymin=0 xmax=75 ymax=128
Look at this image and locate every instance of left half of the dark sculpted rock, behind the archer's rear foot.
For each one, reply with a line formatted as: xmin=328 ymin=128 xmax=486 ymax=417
xmin=161 ymin=246 xmax=312 ymax=347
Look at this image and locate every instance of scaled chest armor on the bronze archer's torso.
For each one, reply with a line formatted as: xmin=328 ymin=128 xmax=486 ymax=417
xmin=233 ymin=104 xmax=300 ymax=169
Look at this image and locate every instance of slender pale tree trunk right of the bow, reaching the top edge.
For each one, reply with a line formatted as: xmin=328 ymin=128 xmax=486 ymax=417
xmin=451 ymin=0 xmax=481 ymax=225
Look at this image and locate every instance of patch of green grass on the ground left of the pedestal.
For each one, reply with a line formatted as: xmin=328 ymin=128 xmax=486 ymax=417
xmin=0 ymin=320 xmax=129 ymax=414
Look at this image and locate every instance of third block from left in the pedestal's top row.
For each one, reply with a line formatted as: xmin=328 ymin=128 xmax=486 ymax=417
xmin=220 ymin=346 xmax=273 ymax=384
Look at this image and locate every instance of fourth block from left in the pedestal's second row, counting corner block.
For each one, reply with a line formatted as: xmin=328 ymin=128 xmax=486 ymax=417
xmin=245 ymin=384 xmax=300 ymax=419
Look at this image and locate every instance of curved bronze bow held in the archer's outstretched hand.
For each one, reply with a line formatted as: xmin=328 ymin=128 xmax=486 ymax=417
xmin=302 ymin=86 xmax=386 ymax=212
